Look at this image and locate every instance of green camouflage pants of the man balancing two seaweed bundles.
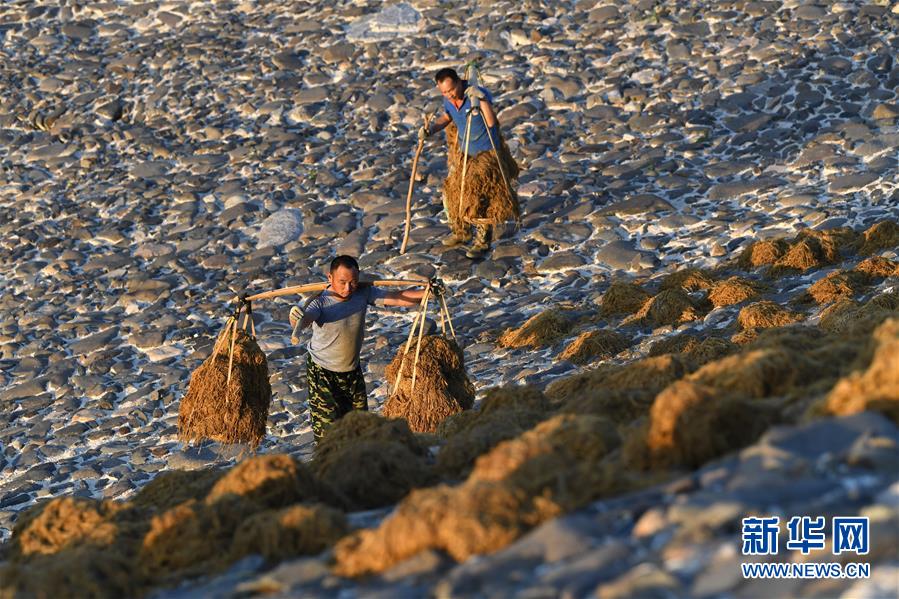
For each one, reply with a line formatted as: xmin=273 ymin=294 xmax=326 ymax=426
xmin=306 ymin=356 xmax=368 ymax=443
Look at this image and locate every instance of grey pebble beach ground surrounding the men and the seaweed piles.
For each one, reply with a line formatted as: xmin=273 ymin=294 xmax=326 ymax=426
xmin=0 ymin=0 xmax=899 ymax=599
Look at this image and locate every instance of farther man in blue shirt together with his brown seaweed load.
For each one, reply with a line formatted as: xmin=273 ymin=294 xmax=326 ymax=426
xmin=419 ymin=68 xmax=520 ymax=259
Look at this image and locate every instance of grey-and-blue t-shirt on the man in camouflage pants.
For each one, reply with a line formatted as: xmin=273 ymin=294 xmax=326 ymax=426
xmin=305 ymin=284 xmax=387 ymax=372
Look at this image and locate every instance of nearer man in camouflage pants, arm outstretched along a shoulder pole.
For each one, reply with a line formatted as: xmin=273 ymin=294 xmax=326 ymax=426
xmin=289 ymin=256 xmax=424 ymax=443
